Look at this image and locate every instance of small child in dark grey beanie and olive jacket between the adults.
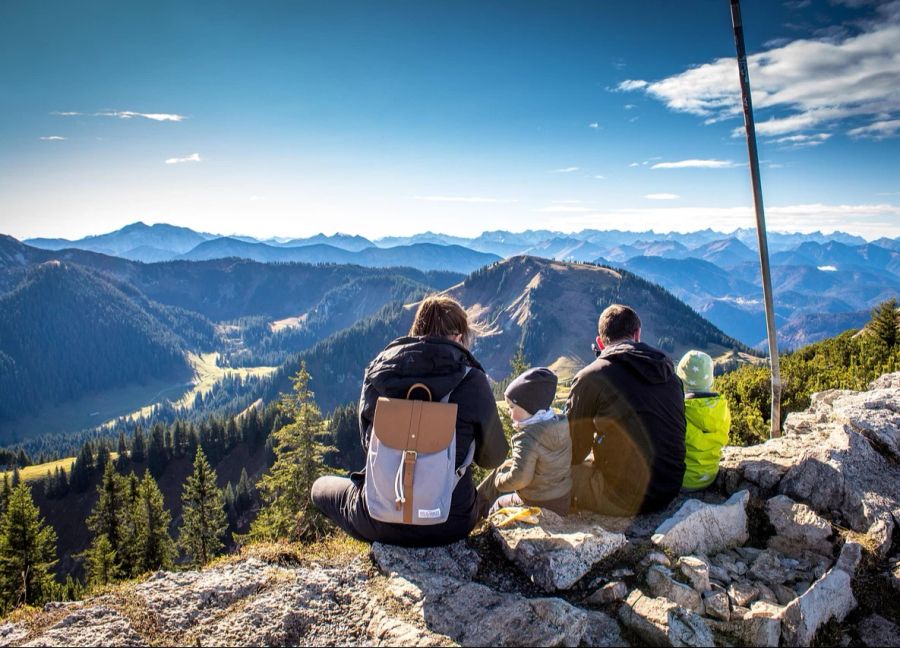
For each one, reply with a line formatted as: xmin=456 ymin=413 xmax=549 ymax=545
xmin=478 ymin=367 xmax=572 ymax=517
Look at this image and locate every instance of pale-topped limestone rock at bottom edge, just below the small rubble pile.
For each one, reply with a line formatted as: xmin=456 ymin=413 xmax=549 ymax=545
xmin=619 ymin=590 xmax=714 ymax=646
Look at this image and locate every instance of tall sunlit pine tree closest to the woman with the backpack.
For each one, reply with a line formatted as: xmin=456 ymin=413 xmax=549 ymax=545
xmin=250 ymin=363 xmax=331 ymax=540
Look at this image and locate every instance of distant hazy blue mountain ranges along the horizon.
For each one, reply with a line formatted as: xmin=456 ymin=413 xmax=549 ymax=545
xmin=26 ymin=223 xmax=900 ymax=348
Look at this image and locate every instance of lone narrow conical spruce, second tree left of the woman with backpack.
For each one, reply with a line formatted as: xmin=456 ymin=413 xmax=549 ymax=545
xmin=178 ymin=448 xmax=228 ymax=565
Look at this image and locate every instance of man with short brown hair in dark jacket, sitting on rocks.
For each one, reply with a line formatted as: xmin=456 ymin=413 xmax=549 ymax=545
xmin=566 ymin=304 xmax=686 ymax=516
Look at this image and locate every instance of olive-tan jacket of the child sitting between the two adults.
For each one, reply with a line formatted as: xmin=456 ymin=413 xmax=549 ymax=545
xmin=494 ymin=415 xmax=572 ymax=502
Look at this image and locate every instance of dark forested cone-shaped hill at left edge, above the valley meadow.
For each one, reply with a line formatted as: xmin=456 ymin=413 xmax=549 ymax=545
xmin=0 ymin=261 xmax=214 ymax=430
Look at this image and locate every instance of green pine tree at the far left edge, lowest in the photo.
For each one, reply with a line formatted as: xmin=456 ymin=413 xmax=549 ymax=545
xmin=0 ymin=484 xmax=56 ymax=608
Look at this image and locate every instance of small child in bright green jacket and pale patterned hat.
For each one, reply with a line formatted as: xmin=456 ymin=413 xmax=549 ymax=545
xmin=675 ymin=350 xmax=731 ymax=491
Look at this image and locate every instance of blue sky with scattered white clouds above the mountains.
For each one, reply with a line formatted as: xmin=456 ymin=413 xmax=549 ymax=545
xmin=0 ymin=0 xmax=900 ymax=238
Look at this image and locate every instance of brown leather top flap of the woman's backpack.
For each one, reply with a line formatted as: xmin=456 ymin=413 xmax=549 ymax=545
xmin=372 ymin=396 xmax=456 ymax=453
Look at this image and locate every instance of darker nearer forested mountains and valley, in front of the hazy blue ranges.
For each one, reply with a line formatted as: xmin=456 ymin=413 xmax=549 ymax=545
xmin=0 ymin=237 xmax=749 ymax=450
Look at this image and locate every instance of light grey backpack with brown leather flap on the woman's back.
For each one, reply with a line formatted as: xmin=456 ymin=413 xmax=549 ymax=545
xmin=364 ymin=374 xmax=475 ymax=526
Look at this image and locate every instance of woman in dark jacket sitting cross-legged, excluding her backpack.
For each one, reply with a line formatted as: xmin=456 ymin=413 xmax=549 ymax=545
xmin=310 ymin=296 xmax=509 ymax=547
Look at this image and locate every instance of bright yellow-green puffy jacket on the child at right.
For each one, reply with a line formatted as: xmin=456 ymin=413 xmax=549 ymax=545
xmin=682 ymin=394 xmax=731 ymax=490
